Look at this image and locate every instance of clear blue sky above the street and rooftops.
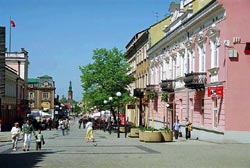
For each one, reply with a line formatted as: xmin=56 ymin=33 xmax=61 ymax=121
xmin=0 ymin=0 xmax=176 ymax=100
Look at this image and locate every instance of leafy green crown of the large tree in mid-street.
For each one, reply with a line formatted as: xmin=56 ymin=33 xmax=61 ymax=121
xmin=79 ymin=48 xmax=134 ymax=108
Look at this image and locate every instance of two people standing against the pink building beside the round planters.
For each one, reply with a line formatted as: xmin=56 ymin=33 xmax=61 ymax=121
xmin=173 ymin=118 xmax=192 ymax=139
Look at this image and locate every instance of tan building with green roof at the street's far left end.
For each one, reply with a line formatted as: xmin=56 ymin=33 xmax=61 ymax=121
xmin=28 ymin=75 xmax=56 ymax=113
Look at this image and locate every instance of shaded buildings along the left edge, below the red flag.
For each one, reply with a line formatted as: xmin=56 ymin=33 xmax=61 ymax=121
xmin=0 ymin=27 xmax=29 ymax=131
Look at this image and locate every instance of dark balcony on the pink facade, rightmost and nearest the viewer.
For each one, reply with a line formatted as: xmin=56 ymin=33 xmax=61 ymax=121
xmin=184 ymin=72 xmax=207 ymax=90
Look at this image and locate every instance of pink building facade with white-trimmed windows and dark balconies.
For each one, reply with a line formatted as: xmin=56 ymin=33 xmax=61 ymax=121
xmin=147 ymin=0 xmax=250 ymax=143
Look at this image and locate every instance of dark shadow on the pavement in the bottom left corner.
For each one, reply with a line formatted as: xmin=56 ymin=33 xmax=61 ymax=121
xmin=0 ymin=152 xmax=54 ymax=168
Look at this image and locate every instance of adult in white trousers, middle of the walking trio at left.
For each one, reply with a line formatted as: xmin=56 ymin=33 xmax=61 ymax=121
xmin=22 ymin=119 xmax=35 ymax=151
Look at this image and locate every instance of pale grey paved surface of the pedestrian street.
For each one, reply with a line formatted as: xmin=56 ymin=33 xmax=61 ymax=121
xmin=0 ymin=121 xmax=250 ymax=168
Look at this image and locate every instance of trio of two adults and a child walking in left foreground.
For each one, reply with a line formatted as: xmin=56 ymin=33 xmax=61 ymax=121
xmin=11 ymin=119 xmax=45 ymax=151
